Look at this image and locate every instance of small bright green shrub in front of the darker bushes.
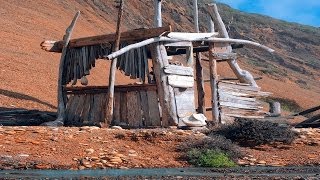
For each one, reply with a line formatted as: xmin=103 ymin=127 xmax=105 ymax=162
xmin=187 ymin=149 xmax=237 ymax=168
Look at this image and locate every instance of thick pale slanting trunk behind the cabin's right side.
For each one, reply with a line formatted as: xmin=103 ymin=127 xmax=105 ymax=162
xmin=208 ymin=4 xmax=258 ymax=87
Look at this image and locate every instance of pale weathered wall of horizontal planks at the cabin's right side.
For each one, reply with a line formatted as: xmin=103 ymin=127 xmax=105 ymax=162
xmin=218 ymin=81 xmax=270 ymax=124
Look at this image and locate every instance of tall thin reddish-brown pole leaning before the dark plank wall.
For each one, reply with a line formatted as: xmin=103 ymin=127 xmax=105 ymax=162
xmin=104 ymin=0 xmax=124 ymax=126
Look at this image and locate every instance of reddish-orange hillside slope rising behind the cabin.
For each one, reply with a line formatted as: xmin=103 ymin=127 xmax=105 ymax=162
xmin=0 ymin=0 xmax=320 ymax=114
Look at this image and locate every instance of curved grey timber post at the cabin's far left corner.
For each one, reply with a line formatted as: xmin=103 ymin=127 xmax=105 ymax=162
xmin=43 ymin=11 xmax=80 ymax=126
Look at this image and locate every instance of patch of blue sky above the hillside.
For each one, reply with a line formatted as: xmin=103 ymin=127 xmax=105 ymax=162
xmin=217 ymin=0 xmax=320 ymax=27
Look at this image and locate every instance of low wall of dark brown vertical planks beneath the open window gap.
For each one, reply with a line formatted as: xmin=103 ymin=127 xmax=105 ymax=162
xmin=66 ymin=85 xmax=161 ymax=128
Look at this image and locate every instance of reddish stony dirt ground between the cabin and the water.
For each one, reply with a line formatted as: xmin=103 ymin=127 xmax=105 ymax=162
xmin=0 ymin=126 xmax=320 ymax=170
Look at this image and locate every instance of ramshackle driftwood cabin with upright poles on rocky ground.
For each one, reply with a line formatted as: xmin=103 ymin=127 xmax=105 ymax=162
xmin=41 ymin=0 xmax=273 ymax=128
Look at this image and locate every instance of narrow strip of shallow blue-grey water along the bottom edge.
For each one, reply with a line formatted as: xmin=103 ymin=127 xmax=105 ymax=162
xmin=0 ymin=166 xmax=320 ymax=179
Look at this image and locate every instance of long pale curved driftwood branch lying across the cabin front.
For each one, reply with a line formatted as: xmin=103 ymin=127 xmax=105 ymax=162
xmin=104 ymin=36 xmax=274 ymax=59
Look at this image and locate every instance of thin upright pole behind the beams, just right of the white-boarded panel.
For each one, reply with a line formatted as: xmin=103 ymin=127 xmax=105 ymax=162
xmin=193 ymin=0 xmax=205 ymax=113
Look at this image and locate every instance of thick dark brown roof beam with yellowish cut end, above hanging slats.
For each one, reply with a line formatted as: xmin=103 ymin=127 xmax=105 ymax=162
xmin=40 ymin=26 xmax=172 ymax=52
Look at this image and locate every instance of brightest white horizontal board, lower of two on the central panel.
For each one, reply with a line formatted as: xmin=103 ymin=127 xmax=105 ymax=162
xmin=168 ymin=75 xmax=194 ymax=88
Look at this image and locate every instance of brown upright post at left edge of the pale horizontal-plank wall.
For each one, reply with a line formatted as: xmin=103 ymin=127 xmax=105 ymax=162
xmin=209 ymin=43 xmax=220 ymax=124
